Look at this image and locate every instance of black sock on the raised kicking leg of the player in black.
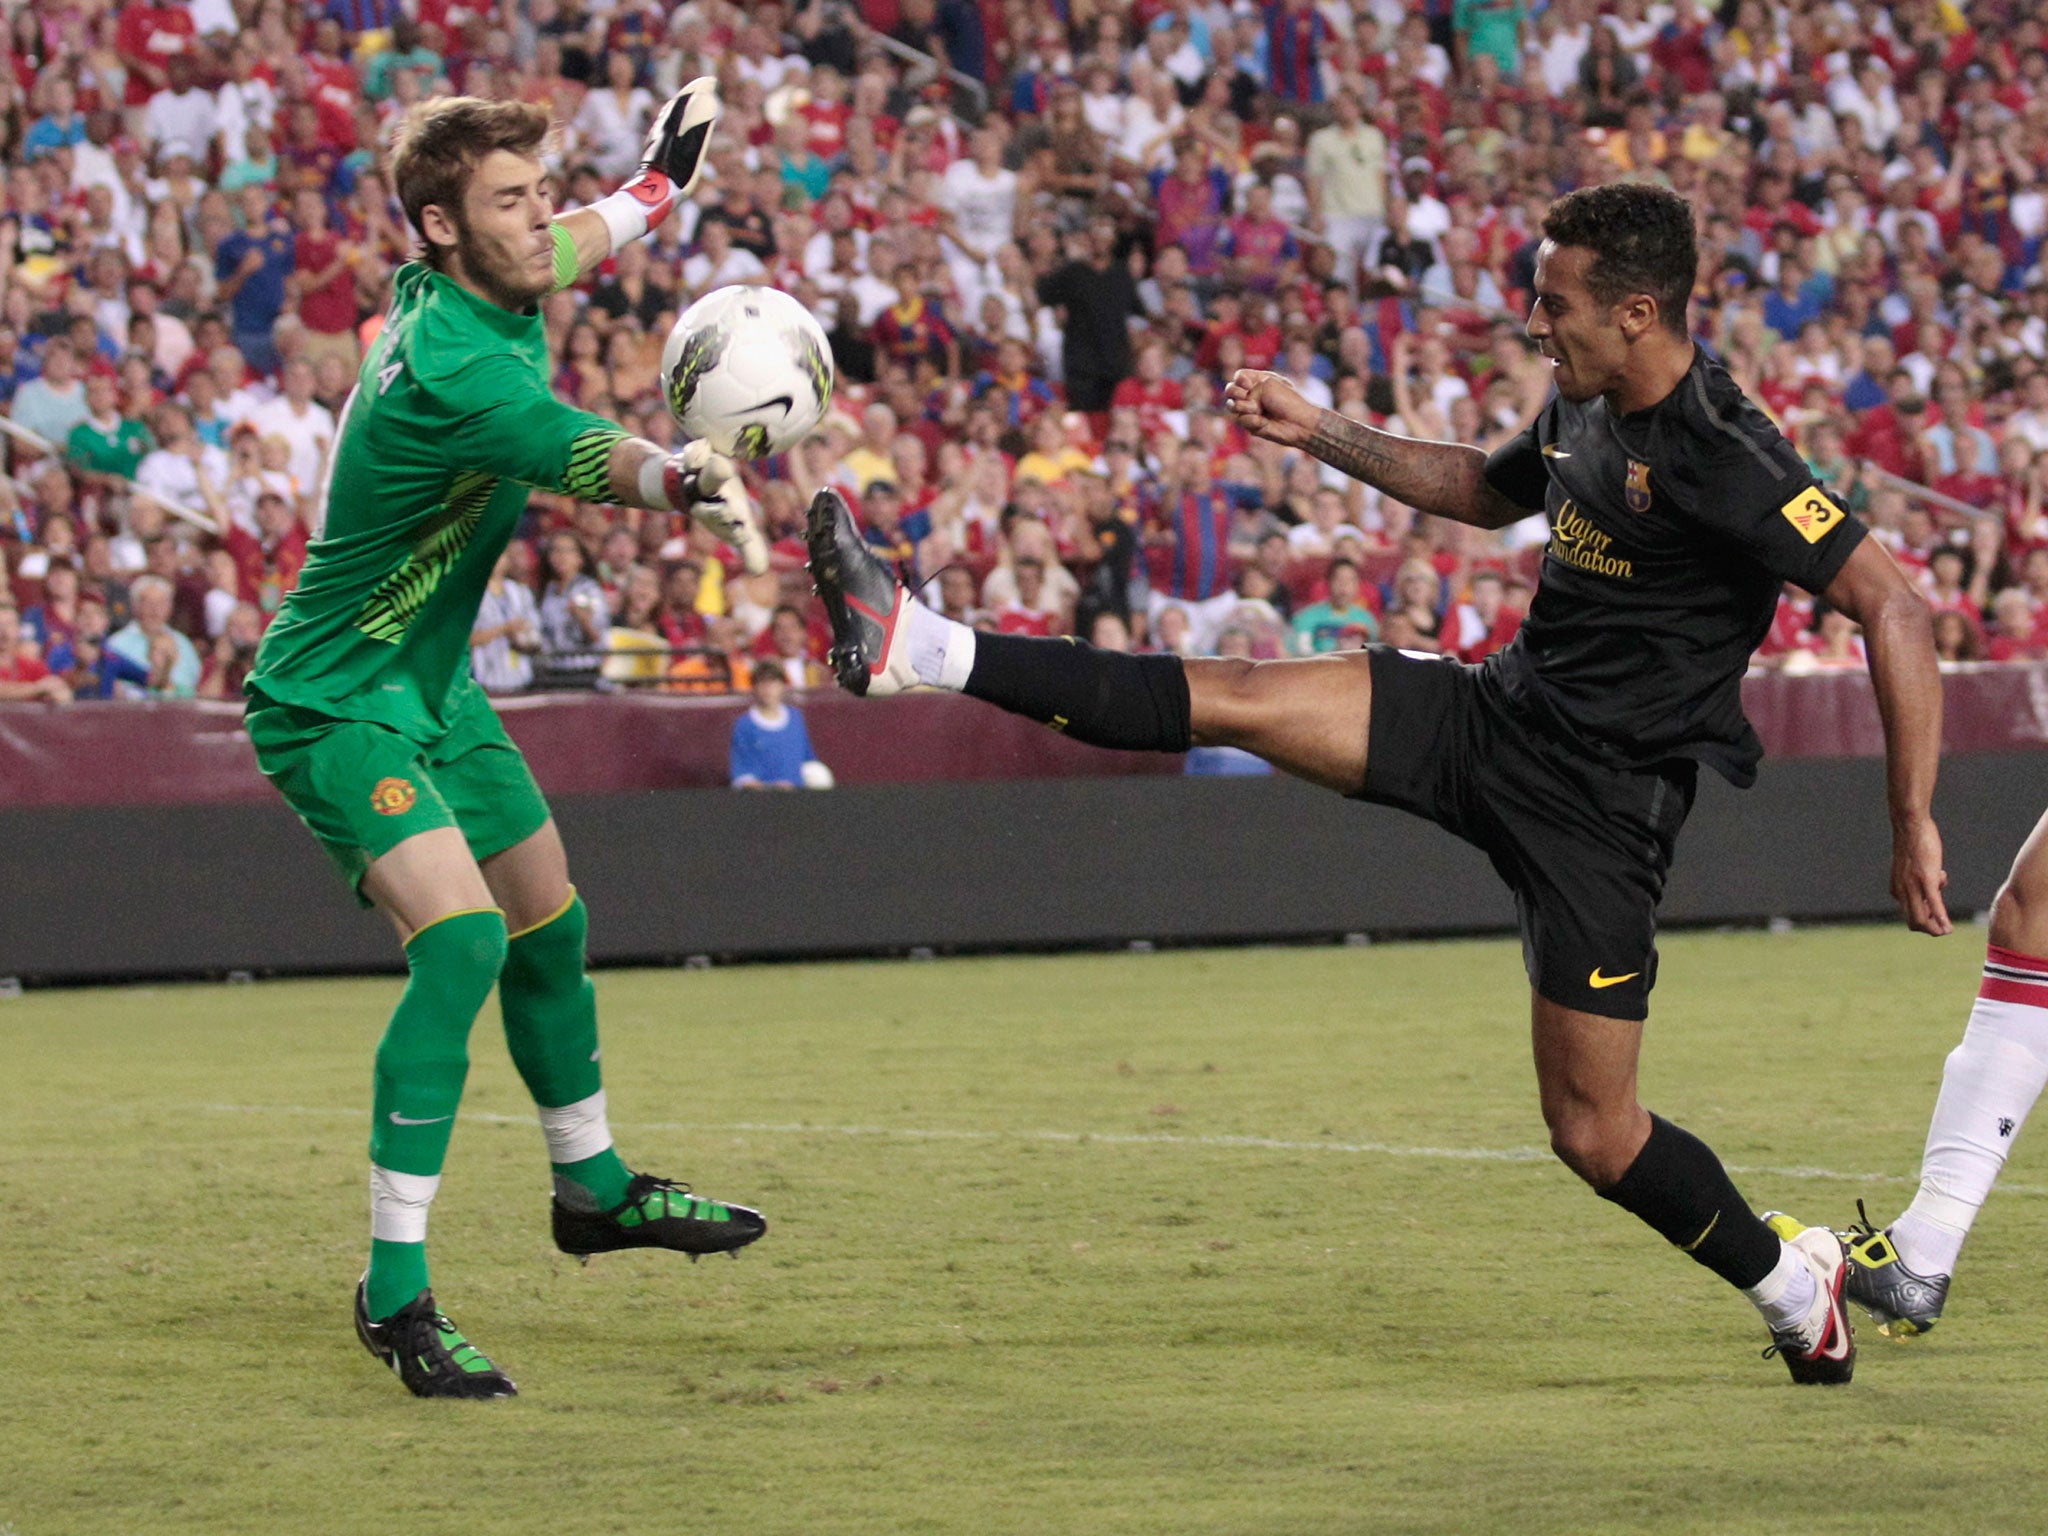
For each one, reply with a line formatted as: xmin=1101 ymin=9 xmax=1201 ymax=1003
xmin=965 ymin=633 xmax=1190 ymax=752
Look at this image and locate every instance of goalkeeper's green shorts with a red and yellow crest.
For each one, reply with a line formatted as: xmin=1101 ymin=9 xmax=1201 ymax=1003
xmin=248 ymin=700 xmax=549 ymax=905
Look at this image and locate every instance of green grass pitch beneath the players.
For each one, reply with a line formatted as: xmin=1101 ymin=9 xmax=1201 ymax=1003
xmin=0 ymin=928 xmax=2048 ymax=1536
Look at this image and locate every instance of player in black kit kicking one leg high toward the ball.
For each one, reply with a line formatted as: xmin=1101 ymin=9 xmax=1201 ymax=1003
xmin=809 ymin=184 xmax=1950 ymax=1382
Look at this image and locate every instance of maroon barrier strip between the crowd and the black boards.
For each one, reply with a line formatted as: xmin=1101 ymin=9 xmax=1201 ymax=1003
xmin=0 ymin=664 xmax=2048 ymax=809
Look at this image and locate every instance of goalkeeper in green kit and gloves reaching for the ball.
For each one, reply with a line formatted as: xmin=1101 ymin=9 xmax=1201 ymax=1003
xmin=248 ymin=80 xmax=768 ymax=1397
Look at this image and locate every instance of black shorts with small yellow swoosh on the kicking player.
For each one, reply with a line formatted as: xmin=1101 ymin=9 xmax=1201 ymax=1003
xmin=1358 ymin=645 xmax=1698 ymax=1020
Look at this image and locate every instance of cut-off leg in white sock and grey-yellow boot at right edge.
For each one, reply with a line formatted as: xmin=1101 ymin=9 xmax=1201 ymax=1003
xmin=1849 ymin=815 xmax=2048 ymax=1337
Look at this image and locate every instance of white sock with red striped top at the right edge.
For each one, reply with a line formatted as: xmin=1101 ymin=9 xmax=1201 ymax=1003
xmin=1890 ymin=944 xmax=2048 ymax=1276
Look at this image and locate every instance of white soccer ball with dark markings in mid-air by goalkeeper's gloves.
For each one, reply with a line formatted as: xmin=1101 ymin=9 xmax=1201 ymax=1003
xmin=662 ymin=285 xmax=831 ymax=459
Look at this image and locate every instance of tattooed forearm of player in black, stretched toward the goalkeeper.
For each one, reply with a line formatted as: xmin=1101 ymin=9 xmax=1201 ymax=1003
xmin=1223 ymin=369 xmax=1532 ymax=528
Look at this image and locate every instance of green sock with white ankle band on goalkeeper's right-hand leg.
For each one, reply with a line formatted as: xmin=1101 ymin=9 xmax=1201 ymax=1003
xmin=498 ymin=891 xmax=633 ymax=1210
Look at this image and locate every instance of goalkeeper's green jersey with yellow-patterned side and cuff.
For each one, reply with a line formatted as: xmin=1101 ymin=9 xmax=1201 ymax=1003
xmin=248 ymin=262 xmax=625 ymax=741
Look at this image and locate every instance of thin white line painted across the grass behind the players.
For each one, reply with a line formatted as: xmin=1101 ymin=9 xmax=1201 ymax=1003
xmin=201 ymin=1104 xmax=2048 ymax=1196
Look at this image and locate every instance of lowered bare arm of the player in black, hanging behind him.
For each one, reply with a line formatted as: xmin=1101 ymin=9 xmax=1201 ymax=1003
xmin=1823 ymin=539 xmax=1954 ymax=936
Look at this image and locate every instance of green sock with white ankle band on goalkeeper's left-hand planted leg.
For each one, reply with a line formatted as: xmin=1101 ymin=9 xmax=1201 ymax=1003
xmin=365 ymin=907 xmax=506 ymax=1321
